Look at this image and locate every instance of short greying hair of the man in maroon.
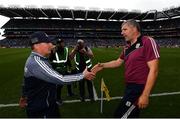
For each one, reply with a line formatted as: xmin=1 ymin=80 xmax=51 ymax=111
xmin=121 ymin=19 xmax=141 ymax=32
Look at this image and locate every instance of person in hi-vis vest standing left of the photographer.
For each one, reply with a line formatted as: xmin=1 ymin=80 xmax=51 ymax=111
xmin=49 ymin=38 xmax=74 ymax=105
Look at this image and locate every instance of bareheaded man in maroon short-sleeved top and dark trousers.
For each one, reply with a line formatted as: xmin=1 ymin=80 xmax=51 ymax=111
xmin=92 ymin=19 xmax=160 ymax=118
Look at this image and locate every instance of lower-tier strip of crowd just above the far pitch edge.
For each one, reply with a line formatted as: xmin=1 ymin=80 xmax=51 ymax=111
xmin=0 ymin=38 xmax=180 ymax=48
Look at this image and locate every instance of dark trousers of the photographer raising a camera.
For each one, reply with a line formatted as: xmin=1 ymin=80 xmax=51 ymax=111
xmin=79 ymin=79 xmax=94 ymax=99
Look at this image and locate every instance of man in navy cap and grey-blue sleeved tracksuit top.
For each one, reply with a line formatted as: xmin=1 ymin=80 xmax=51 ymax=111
xmin=20 ymin=32 xmax=94 ymax=118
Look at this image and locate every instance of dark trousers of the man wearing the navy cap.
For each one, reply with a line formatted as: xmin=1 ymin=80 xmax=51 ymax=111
xmin=26 ymin=104 xmax=60 ymax=118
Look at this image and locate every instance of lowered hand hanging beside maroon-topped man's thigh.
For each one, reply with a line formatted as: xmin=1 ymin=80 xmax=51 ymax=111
xmin=137 ymin=95 xmax=149 ymax=109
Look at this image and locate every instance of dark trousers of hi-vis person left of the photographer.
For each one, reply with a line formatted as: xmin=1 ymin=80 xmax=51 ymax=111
xmin=57 ymin=84 xmax=73 ymax=100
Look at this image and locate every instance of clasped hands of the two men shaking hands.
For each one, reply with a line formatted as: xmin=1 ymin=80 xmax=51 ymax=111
xmin=83 ymin=63 xmax=104 ymax=80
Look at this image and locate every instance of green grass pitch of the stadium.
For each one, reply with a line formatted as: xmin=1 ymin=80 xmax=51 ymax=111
xmin=0 ymin=48 xmax=180 ymax=118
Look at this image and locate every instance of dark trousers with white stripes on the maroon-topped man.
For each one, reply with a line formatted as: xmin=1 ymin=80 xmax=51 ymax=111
xmin=114 ymin=83 xmax=144 ymax=118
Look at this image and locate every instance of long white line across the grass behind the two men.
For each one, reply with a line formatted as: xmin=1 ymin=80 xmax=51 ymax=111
xmin=0 ymin=91 xmax=180 ymax=108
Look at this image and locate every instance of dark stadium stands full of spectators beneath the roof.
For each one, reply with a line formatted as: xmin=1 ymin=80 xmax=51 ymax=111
xmin=0 ymin=18 xmax=180 ymax=47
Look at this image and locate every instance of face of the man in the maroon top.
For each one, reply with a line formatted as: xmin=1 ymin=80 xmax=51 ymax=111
xmin=121 ymin=24 xmax=135 ymax=41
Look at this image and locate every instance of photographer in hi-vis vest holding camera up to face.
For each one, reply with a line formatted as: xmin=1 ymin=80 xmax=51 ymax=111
xmin=70 ymin=39 xmax=94 ymax=102
